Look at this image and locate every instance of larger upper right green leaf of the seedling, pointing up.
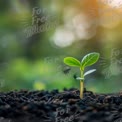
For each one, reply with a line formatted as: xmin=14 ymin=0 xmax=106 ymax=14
xmin=81 ymin=52 xmax=100 ymax=69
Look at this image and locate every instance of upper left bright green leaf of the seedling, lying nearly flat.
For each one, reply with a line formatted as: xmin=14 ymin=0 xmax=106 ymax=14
xmin=64 ymin=57 xmax=81 ymax=67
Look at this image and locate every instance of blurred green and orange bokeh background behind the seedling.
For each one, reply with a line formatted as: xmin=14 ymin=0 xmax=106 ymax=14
xmin=0 ymin=0 xmax=122 ymax=93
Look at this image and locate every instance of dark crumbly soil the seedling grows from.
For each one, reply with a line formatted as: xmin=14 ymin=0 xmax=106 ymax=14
xmin=0 ymin=89 xmax=122 ymax=122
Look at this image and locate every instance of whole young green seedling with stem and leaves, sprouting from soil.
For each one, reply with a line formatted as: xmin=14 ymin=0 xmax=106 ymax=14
xmin=64 ymin=52 xmax=100 ymax=99
